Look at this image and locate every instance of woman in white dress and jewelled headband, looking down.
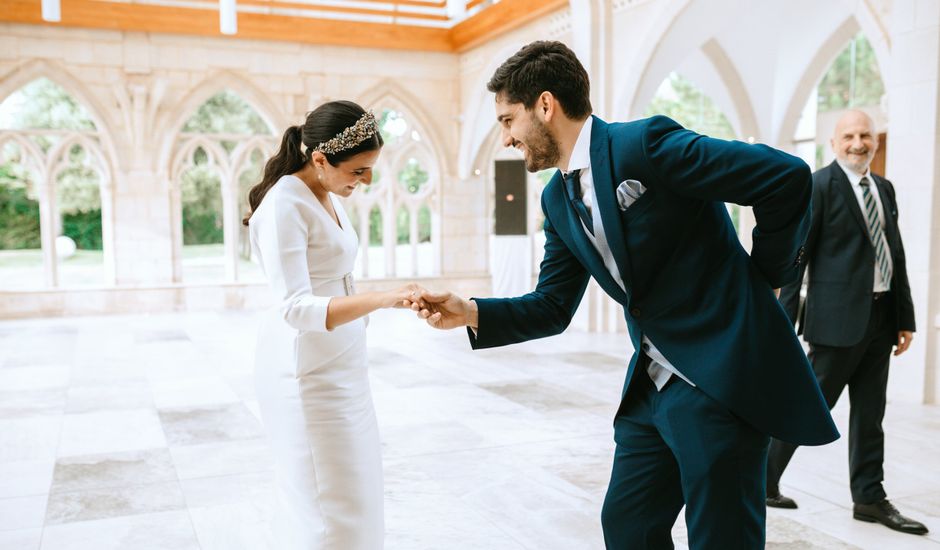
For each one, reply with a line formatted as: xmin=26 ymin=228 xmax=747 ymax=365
xmin=245 ymin=101 xmax=417 ymax=550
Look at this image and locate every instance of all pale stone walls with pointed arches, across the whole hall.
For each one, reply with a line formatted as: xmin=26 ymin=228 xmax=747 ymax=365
xmin=0 ymin=0 xmax=940 ymax=401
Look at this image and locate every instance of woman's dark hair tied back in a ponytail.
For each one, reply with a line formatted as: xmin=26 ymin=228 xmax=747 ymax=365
xmin=242 ymin=101 xmax=384 ymax=225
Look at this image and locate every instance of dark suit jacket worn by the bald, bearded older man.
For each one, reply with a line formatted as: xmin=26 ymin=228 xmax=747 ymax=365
xmin=780 ymin=161 xmax=915 ymax=347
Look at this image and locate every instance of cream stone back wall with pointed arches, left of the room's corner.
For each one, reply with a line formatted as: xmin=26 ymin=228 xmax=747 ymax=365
xmin=0 ymin=24 xmax=466 ymax=287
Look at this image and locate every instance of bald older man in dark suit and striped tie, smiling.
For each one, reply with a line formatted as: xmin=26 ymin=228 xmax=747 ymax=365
xmin=767 ymin=111 xmax=927 ymax=535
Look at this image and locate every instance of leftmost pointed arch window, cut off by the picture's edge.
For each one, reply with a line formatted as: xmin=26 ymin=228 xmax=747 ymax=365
xmin=0 ymin=77 xmax=114 ymax=290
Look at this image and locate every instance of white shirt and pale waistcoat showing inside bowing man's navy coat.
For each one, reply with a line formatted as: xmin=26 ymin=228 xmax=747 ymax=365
xmin=568 ymin=117 xmax=695 ymax=390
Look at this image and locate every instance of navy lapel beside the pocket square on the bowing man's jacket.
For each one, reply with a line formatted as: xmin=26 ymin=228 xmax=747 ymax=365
xmin=591 ymin=117 xmax=632 ymax=300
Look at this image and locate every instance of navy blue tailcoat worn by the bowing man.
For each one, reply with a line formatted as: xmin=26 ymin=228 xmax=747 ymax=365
xmin=470 ymin=116 xmax=838 ymax=445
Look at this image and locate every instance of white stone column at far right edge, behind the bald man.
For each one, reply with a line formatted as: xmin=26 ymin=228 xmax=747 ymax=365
xmin=886 ymin=0 xmax=940 ymax=403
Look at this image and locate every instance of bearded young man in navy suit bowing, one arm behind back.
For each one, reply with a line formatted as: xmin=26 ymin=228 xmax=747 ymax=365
xmin=412 ymin=42 xmax=838 ymax=550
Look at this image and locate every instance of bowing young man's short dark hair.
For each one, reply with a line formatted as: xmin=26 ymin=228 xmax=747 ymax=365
xmin=486 ymin=40 xmax=592 ymax=120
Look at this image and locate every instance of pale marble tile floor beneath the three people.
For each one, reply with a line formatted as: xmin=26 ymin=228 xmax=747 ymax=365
xmin=0 ymin=311 xmax=940 ymax=550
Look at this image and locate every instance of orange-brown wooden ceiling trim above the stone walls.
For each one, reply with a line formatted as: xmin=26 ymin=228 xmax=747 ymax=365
xmin=0 ymin=0 xmax=568 ymax=52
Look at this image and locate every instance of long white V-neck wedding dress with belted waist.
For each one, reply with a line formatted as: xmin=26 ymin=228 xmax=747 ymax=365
xmin=250 ymin=176 xmax=384 ymax=550
